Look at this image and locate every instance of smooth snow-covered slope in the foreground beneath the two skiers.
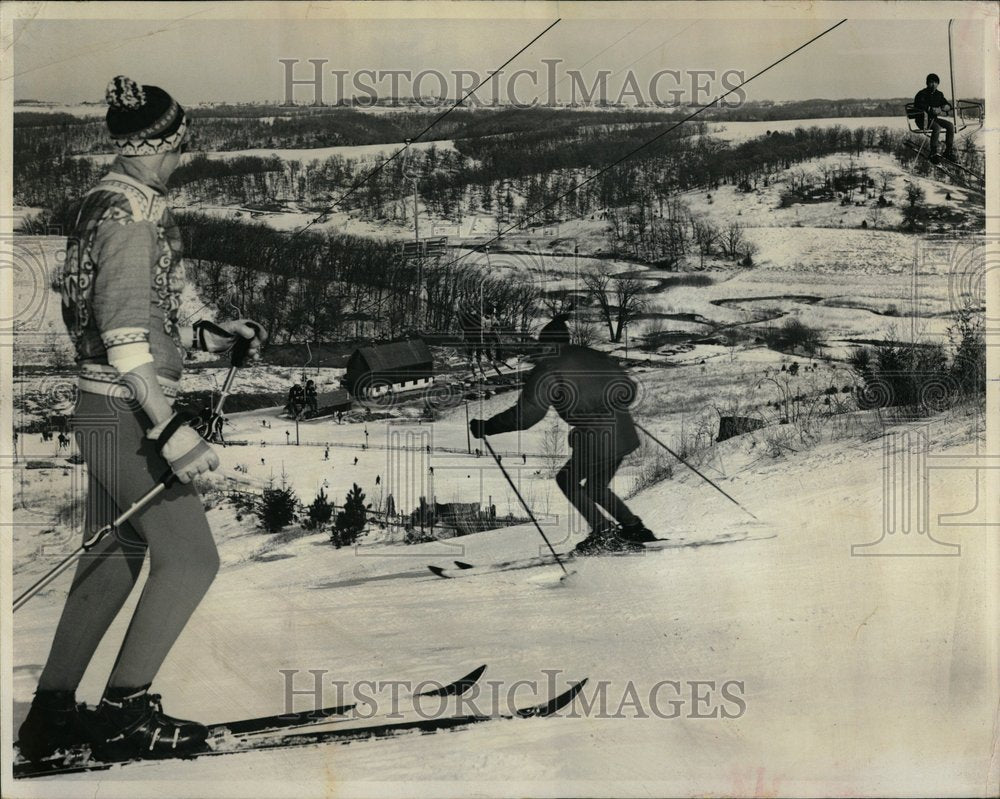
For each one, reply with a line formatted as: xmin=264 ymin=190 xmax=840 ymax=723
xmin=14 ymin=416 xmax=997 ymax=797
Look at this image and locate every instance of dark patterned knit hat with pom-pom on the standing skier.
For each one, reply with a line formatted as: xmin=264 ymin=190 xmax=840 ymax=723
xmin=104 ymin=75 xmax=188 ymax=155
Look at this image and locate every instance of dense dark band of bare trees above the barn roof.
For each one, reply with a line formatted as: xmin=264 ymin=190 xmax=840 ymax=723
xmin=178 ymin=213 xmax=540 ymax=343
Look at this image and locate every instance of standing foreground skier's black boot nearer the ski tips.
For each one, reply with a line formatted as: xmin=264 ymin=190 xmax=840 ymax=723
xmin=92 ymin=686 xmax=208 ymax=761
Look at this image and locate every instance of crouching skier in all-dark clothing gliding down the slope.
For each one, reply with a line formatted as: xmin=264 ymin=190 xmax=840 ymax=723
xmin=469 ymin=316 xmax=655 ymax=554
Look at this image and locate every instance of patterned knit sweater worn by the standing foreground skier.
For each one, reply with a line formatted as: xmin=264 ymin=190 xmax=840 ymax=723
xmin=55 ymin=158 xmax=184 ymax=396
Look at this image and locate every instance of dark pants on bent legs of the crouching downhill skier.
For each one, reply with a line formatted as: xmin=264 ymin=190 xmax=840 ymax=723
xmin=556 ymin=429 xmax=641 ymax=531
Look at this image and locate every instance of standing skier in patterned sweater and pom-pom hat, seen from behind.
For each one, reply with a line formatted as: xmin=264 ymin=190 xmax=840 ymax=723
xmin=18 ymin=76 xmax=264 ymax=760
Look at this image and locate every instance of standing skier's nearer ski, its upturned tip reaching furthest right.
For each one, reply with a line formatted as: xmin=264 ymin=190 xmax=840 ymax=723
xmin=14 ymin=678 xmax=587 ymax=779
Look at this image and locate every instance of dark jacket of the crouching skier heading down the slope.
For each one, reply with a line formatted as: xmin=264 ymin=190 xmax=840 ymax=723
xmin=485 ymin=344 xmax=639 ymax=457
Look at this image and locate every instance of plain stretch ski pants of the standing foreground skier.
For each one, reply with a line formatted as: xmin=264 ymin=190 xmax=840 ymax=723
xmin=38 ymin=391 xmax=219 ymax=690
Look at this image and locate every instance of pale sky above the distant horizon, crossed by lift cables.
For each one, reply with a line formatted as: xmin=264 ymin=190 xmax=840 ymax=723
xmin=13 ymin=15 xmax=985 ymax=104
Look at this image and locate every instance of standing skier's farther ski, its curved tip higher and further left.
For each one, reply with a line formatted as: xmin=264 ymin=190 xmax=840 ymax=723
xmin=14 ymin=664 xmax=486 ymax=776
